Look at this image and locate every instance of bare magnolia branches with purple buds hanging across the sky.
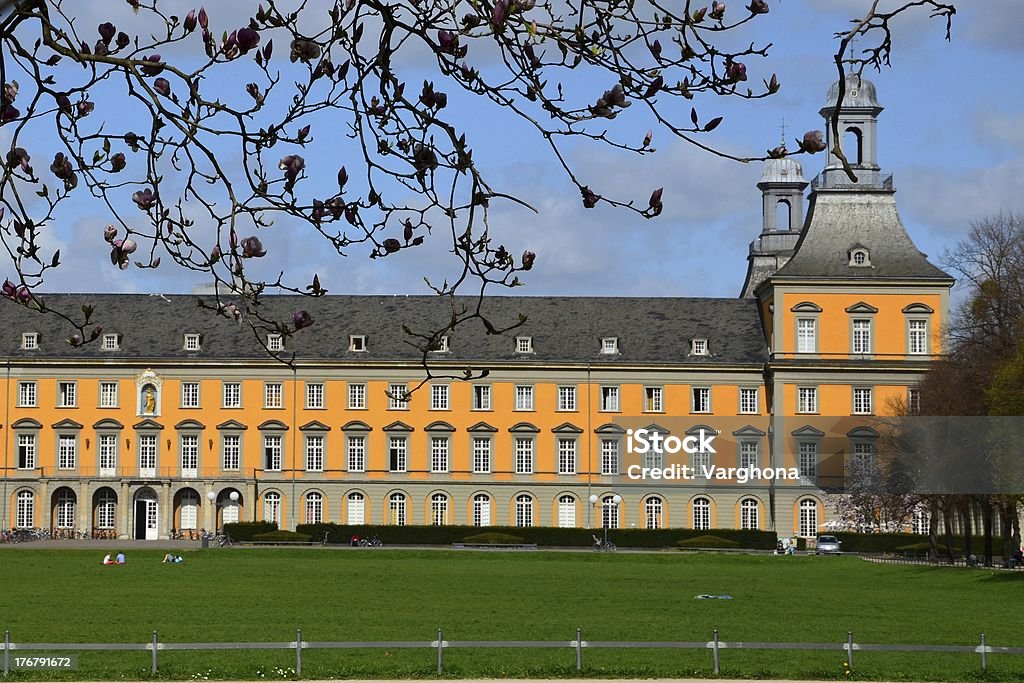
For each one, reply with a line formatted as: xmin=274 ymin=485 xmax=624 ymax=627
xmin=0 ymin=0 xmax=954 ymax=375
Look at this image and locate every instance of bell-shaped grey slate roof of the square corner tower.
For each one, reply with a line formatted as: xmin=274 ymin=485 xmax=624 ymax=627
xmin=775 ymin=189 xmax=953 ymax=282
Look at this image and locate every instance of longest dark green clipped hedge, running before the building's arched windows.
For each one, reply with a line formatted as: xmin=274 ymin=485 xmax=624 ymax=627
xmin=296 ymin=523 xmax=775 ymax=550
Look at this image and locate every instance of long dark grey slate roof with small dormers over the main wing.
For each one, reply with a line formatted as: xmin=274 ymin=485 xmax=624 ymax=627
xmin=0 ymin=294 xmax=767 ymax=366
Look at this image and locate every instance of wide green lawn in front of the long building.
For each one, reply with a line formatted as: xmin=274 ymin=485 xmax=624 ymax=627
xmin=0 ymin=548 xmax=1024 ymax=680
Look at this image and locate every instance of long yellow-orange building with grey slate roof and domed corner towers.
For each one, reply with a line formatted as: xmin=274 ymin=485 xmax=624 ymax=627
xmin=0 ymin=77 xmax=952 ymax=539
